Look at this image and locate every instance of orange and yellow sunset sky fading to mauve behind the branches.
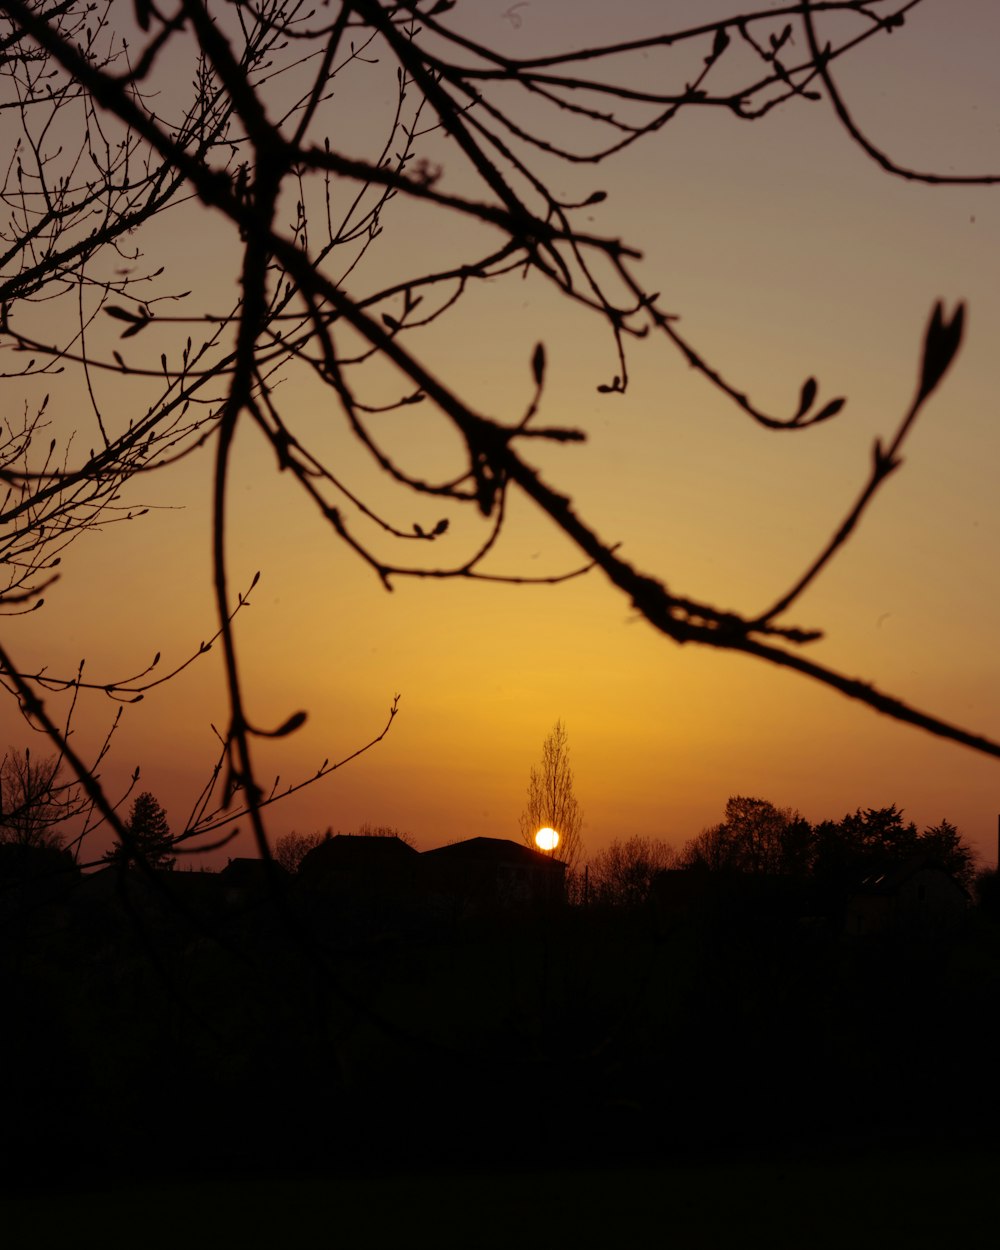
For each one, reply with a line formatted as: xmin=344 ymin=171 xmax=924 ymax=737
xmin=0 ymin=0 xmax=1000 ymax=864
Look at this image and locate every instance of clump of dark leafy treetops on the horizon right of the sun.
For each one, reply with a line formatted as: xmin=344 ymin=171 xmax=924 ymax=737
xmin=583 ymin=795 xmax=975 ymax=906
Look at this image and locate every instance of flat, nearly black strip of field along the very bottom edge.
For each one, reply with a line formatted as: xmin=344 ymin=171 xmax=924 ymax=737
xmin=0 ymin=1153 xmax=1000 ymax=1250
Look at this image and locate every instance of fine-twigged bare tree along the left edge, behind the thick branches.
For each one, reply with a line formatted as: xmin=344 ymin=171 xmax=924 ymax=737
xmin=0 ymin=0 xmax=409 ymax=848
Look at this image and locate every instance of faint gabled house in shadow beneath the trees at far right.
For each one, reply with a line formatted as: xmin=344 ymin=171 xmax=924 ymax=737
xmin=845 ymin=855 xmax=971 ymax=938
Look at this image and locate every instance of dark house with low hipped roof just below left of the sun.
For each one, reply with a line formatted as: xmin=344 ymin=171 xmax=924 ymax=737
xmin=420 ymin=838 xmax=566 ymax=911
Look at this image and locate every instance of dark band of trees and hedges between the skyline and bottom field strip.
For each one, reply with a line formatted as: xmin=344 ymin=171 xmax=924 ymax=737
xmin=0 ymin=799 xmax=1000 ymax=1189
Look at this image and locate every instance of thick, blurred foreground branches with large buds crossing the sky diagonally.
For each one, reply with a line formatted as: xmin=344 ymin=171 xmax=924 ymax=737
xmin=0 ymin=0 xmax=1000 ymax=851
